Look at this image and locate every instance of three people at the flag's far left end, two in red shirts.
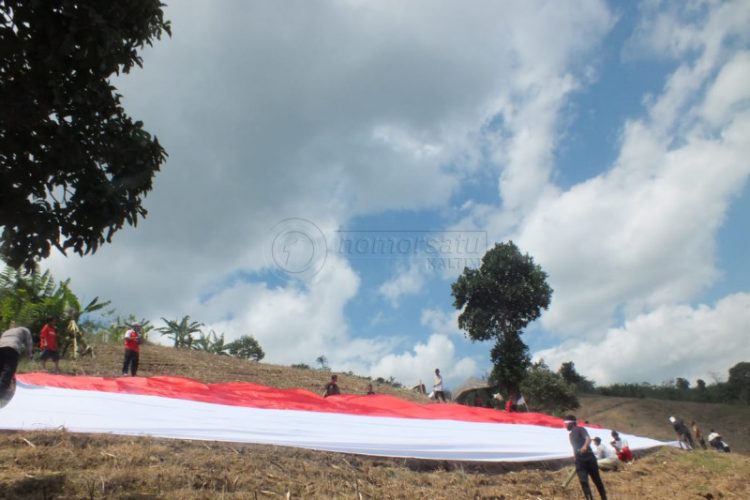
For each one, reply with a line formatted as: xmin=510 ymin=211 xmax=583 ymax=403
xmin=0 ymin=318 xmax=143 ymax=394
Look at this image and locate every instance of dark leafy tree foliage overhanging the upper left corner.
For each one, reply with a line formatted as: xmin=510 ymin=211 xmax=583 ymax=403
xmin=0 ymin=0 xmax=170 ymax=270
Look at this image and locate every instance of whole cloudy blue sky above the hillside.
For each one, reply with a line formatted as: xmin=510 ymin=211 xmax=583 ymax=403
xmin=42 ymin=0 xmax=750 ymax=389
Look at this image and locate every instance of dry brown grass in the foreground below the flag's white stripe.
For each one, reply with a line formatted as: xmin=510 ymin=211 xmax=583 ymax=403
xmin=0 ymin=431 xmax=750 ymax=499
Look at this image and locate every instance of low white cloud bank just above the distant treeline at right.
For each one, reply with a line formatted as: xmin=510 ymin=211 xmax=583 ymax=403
xmin=535 ymin=293 xmax=750 ymax=384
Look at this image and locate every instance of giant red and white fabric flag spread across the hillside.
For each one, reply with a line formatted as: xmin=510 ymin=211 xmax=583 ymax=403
xmin=0 ymin=373 xmax=667 ymax=462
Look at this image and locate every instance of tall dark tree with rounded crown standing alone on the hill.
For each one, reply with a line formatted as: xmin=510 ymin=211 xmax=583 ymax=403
xmin=451 ymin=241 xmax=552 ymax=392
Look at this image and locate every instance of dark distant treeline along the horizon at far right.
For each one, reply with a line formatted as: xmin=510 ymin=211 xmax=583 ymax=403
xmin=558 ymin=362 xmax=750 ymax=405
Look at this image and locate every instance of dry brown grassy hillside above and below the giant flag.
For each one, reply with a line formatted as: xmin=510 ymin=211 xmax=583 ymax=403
xmin=0 ymin=345 xmax=750 ymax=499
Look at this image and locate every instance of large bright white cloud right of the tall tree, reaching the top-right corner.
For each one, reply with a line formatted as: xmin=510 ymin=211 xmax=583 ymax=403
xmin=469 ymin=3 xmax=750 ymax=338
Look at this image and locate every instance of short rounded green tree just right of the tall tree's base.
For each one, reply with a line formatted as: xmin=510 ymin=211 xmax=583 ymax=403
xmin=521 ymin=361 xmax=580 ymax=415
